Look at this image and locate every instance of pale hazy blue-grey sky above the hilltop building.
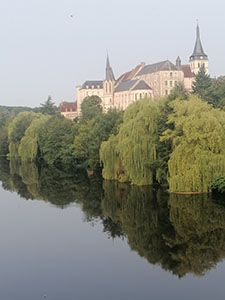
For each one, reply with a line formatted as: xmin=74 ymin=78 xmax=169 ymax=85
xmin=0 ymin=0 xmax=225 ymax=107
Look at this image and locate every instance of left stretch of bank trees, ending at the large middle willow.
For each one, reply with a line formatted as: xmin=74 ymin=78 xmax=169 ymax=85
xmin=0 ymin=96 xmax=122 ymax=170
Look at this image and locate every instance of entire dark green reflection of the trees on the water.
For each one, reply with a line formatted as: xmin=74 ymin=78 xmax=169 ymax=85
xmin=0 ymin=160 xmax=225 ymax=277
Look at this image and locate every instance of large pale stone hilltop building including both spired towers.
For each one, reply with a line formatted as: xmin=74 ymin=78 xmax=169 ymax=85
xmin=76 ymin=25 xmax=208 ymax=115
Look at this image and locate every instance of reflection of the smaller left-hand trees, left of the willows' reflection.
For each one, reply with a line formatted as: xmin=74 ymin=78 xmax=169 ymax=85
xmin=0 ymin=159 xmax=123 ymax=238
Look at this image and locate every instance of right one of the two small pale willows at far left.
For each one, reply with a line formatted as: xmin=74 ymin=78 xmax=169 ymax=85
xmin=18 ymin=115 xmax=50 ymax=161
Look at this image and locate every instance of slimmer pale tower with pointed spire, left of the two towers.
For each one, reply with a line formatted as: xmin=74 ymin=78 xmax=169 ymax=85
xmin=103 ymin=54 xmax=116 ymax=112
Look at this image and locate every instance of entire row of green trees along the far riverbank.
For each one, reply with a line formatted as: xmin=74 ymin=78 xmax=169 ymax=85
xmin=0 ymin=68 xmax=225 ymax=192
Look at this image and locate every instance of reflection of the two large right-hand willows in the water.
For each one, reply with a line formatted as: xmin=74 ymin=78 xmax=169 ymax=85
xmin=102 ymin=181 xmax=225 ymax=277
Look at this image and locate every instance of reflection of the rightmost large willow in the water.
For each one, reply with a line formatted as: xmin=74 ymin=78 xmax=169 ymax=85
xmin=166 ymin=194 xmax=225 ymax=276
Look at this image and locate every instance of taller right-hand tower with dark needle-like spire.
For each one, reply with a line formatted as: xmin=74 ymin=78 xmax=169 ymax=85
xmin=189 ymin=24 xmax=209 ymax=75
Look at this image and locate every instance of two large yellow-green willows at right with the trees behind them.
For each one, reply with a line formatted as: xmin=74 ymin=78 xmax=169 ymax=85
xmin=100 ymin=68 xmax=225 ymax=192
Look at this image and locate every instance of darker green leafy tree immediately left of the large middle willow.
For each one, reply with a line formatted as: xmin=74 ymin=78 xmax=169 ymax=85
xmin=73 ymin=110 xmax=122 ymax=169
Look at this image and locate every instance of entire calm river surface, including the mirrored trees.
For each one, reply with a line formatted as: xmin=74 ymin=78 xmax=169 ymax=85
xmin=0 ymin=161 xmax=225 ymax=300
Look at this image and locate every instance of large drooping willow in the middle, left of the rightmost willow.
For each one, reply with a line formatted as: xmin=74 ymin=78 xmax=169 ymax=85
xmin=100 ymin=99 xmax=167 ymax=185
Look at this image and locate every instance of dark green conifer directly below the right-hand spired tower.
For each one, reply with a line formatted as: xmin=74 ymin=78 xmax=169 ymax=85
xmin=192 ymin=65 xmax=212 ymax=99
